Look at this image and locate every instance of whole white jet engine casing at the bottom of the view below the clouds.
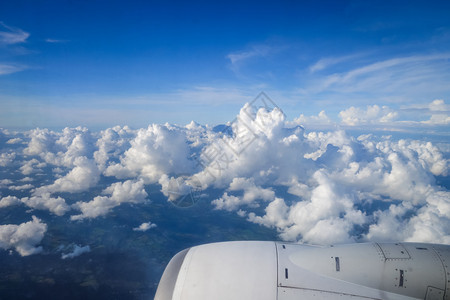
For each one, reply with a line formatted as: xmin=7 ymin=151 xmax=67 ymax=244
xmin=155 ymin=241 xmax=450 ymax=300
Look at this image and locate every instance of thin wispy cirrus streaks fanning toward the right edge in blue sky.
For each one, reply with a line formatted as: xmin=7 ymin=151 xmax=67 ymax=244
xmin=299 ymin=52 xmax=450 ymax=108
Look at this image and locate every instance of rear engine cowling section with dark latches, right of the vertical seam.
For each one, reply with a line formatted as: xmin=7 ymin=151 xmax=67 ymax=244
xmin=278 ymin=243 xmax=450 ymax=300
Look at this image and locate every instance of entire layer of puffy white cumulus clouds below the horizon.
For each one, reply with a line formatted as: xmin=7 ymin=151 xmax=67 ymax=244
xmin=0 ymin=99 xmax=450 ymax=257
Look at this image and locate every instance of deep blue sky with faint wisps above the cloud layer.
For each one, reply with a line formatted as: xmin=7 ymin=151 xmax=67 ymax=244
xmin=0 ymin=0 xmax=450 ymax=131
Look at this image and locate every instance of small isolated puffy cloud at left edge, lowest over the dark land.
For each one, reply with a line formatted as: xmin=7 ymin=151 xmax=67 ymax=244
xmin=0 ymin=216 xmax=47 ymax=256
